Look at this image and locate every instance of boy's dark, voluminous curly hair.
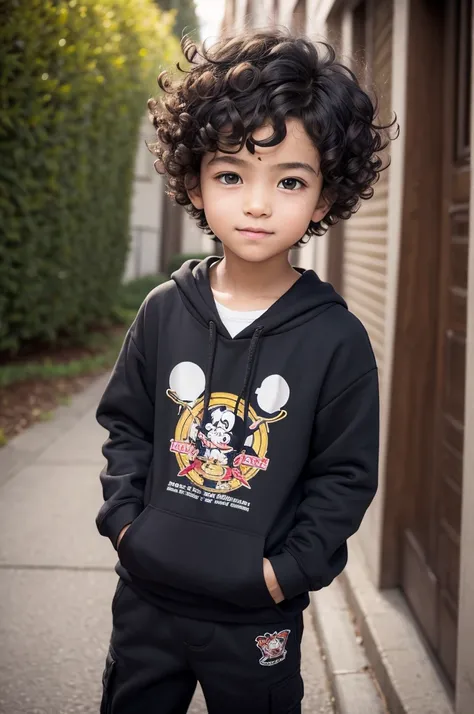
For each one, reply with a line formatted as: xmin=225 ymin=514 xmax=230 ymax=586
xmin=148 ymin=29 xmax=396 ymax=244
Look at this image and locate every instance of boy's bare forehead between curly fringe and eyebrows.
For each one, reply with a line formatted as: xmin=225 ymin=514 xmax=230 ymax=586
xmin=205 ymin=119 xmax=319 ymax=168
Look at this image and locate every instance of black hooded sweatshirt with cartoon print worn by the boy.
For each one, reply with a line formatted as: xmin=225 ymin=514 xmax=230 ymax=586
xmin=97 ymin=258 xmax=379 ymax=622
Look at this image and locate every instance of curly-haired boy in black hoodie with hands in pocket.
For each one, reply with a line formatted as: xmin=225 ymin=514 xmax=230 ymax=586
xmin=97 ymin=30 xmax=392 ymax=714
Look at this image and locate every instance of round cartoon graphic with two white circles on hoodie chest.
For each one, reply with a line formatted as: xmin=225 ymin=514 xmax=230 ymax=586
xmin=166 ymin=362 xmax=290 ymax=492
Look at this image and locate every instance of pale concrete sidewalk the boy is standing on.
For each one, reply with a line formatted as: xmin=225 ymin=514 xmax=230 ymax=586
xmin=0 ymin=377 xmax=366 ymax=714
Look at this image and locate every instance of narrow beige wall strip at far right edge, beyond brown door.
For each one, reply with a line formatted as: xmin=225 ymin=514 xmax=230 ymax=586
xmin=456 ymin=8 xmax=474 ymax=714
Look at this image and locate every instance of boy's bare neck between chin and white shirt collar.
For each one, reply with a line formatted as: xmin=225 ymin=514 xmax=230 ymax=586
xmin=211 ymin=250 xmax=300 ymax=299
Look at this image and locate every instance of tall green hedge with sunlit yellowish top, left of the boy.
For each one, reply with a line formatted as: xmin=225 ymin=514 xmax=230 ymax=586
xmin=0 ymin=0 xmax=178 ymax=351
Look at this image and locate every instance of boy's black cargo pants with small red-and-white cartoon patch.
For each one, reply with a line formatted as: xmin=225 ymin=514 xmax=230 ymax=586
xmin=100 ymin=580 xmax=303 ymax=714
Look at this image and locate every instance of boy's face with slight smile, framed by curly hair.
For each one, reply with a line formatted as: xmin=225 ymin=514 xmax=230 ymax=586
xmin=189 ymin=119 xmax=329 ymax=262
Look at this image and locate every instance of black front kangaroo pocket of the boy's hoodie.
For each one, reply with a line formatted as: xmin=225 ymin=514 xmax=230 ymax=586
xmin=119 ymin=504 xmax=275 ymax=607
